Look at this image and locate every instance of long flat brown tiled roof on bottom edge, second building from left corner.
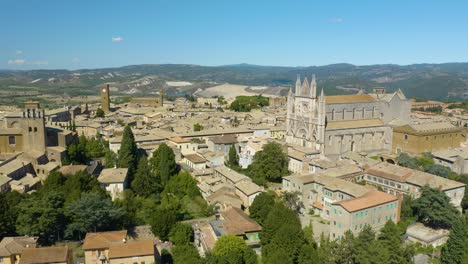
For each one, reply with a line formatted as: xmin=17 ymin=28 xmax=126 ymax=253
xmin=19 ymin=247 xmax=71 ymax=264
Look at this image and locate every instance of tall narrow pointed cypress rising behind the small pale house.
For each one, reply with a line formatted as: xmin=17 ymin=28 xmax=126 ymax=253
xmin=118 ymin=126 xmax=138 ymax=179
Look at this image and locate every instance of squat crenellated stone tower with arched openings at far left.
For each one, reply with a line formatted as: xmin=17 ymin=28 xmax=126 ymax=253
xmin=21 ymin=101 xmax=46 ymax=152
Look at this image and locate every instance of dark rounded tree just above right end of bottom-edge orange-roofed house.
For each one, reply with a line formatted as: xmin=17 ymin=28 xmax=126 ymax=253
xmin=151 ymin=208 xmax=177 ymax=241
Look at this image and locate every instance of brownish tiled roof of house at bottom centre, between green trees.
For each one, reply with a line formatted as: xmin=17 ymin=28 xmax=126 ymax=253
xmin=221 ymin=207 xmax=262 ymax=235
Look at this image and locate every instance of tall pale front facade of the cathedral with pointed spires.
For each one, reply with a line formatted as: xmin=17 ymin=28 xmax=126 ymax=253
xmin=286 ymin=75 xmax=326 ymax=153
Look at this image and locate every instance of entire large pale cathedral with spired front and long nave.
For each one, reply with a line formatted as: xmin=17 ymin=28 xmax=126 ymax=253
xmin=286 ymin=73 xmax=411 ymax=162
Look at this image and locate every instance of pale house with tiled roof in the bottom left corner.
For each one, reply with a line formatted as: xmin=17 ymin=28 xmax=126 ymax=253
xmin=0 ymin=236 xmax=38 ymax=264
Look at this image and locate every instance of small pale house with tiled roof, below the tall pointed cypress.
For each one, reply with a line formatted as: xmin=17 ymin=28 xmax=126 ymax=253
xmin=98 ymin=168 xmax=128 ymax=200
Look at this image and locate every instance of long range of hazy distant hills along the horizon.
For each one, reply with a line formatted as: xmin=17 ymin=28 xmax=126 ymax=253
xmin=0 ymin=63 xmax=468 ymax=100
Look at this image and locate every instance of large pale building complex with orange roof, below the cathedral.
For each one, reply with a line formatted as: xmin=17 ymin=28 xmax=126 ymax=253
xmin=282 ymin=173 xmax=400 ymax=240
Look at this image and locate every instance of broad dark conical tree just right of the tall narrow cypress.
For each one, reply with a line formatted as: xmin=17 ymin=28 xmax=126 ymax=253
xmin=151 ymin=143 xmax=179 ymax=187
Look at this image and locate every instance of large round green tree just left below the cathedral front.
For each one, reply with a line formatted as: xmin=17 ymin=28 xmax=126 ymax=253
xmin=247 ymin=142 xmax=289 ymax=185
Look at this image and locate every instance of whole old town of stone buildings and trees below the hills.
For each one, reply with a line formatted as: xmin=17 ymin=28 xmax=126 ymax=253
xmin=0 ymin=75 xmax=468 ymax=264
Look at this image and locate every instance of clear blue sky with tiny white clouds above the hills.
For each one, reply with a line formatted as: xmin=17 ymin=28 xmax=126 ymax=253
xmin=0 ymin=0 xmax=468 ymax=69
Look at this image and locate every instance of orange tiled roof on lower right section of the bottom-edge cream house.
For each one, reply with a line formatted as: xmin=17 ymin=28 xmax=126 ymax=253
xmin=109 ymin=240 xmax=154 ymax=259
